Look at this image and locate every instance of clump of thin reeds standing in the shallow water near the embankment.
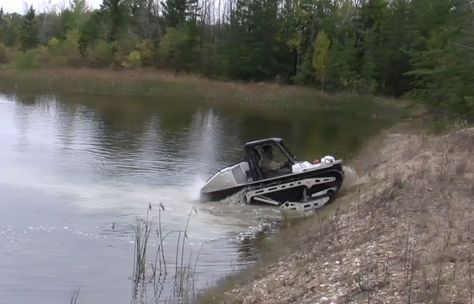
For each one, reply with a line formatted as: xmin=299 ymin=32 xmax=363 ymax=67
xmin=124 ymin=203 xmax=202 ymax=303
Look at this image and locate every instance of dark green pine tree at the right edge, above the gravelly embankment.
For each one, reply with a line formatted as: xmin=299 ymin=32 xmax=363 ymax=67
xmin=407 ymin=0 xmax=474 ymax=113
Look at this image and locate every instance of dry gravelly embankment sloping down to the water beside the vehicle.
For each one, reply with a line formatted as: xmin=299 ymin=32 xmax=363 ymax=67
xmin=200 ymin=129 xmax=474 ymax=303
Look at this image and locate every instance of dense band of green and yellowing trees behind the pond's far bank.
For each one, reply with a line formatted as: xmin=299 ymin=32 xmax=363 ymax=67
xmin=0 ymin=0 xmax=474 ymax=115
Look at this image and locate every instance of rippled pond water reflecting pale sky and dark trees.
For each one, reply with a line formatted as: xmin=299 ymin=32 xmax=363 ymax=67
xmin=0 ymin=89 xmax=398 ymax=303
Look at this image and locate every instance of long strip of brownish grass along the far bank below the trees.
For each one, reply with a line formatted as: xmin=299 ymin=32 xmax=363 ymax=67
xmin=0 ymin=67 xmax=403 ymax=107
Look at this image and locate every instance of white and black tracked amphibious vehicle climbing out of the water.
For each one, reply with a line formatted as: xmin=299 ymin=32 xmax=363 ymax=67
xmin=201 ymin=138 xmax=344 ymax=210
